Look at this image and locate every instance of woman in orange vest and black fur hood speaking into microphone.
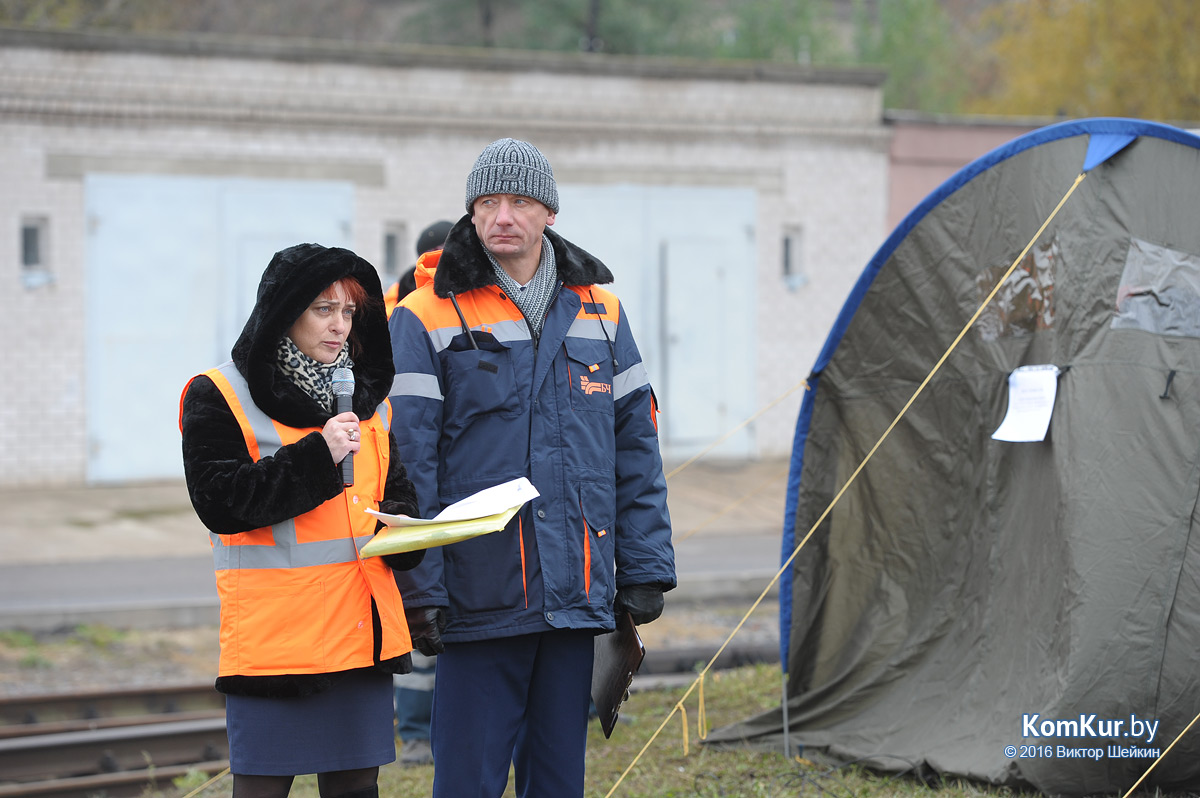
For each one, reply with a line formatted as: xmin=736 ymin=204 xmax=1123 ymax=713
xmin=180 ymin=244 xmax=424 ymax=798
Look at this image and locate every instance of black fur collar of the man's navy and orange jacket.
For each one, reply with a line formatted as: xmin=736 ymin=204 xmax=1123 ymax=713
xmin=433 ymin=214 xmax=612 ymax=299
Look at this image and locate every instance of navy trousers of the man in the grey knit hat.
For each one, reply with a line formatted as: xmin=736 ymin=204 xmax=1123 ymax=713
xmin=432 ymin=630 xmax=595 ymax=798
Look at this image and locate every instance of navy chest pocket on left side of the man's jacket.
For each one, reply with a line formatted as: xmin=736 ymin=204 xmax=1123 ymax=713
xmin=442 ymin=330 xmax=521 ymax=420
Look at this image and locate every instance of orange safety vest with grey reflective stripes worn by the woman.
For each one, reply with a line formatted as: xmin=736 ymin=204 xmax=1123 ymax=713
xmin=184 ymin=361 xmax=413 ymax=676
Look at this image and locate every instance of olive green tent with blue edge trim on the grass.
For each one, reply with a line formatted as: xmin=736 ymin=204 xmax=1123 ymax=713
xmin=709 ymin=119 xmax=1200 ymax=794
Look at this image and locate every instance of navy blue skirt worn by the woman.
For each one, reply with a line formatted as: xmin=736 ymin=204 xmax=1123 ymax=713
xmin=226 ymin=668 xmax=396 ymax=776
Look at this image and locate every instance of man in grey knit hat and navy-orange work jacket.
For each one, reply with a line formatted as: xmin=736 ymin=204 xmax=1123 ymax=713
xmin=390 ymin=139 xmax=676 ymax=798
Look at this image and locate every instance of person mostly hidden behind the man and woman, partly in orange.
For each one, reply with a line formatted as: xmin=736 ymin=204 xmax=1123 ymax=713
xmin=384 ymin=221 xmax=454 ymax=767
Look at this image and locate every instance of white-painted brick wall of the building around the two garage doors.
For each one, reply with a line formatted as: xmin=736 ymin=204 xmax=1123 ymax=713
xmin=0 ymin=31 xmax=888 ymax=486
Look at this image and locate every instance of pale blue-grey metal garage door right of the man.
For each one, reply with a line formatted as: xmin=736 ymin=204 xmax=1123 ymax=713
xmin=554 ymin=185 xmax=757 ymax=458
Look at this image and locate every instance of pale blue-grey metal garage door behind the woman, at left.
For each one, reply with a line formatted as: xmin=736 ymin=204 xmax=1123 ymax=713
xmin=84 ymin=174 xmax=354 ymax=482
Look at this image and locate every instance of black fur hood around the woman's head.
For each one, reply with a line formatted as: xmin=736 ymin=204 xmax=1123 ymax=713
xmin=232 ymin=244 xmax=395 ymax=427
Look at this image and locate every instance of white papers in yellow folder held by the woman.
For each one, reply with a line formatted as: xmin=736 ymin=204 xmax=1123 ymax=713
xmin=361 ymin=476 xmax=540 ymax=557
